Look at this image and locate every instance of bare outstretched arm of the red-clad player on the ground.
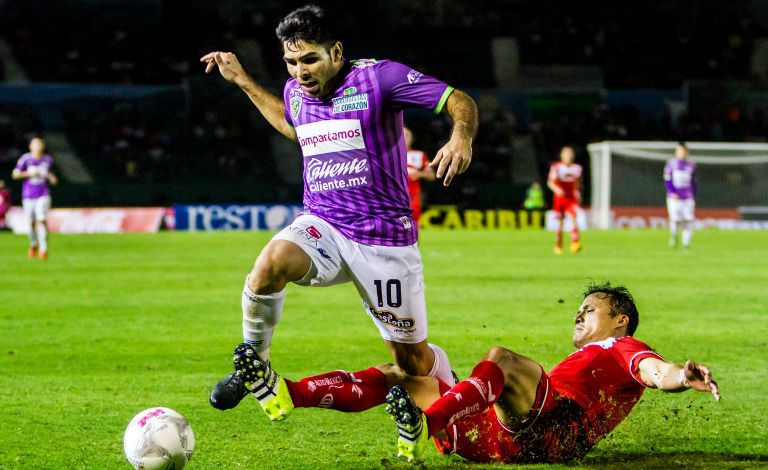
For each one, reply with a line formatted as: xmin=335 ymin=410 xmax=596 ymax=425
xmin=638 ymin=357 xmax=720 ymax=401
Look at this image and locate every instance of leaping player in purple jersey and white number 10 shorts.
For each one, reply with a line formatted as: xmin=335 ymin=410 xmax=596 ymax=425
xmin=200 ymin=6 xmax=478 ymax=420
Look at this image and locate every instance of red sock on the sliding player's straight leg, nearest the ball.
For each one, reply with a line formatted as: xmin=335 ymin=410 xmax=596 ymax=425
xmin=285 ymin=367 xmax=389 ymax=412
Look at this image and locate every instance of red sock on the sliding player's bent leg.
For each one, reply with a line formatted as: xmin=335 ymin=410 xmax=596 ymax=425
xmin=424 ymin=361 xmax=504 ymax=435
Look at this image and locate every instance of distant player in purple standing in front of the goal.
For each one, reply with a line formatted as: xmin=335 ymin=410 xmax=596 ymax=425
xmin=664 ymin=142 xmax=696 ymax=248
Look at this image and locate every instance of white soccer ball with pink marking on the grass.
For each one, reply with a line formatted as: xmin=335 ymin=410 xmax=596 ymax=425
xmin=123 ymin=406 xmax=195 ymax=470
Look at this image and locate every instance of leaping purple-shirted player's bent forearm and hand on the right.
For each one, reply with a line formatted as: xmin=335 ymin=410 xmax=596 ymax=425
xmin=430 ymin=90 xmax=478 ymax=186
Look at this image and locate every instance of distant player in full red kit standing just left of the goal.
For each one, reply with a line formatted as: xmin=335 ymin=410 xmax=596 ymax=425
xmin=547 ymin=145 xmax=582 ymax=255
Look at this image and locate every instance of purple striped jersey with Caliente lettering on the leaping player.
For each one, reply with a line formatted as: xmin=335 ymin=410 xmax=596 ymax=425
xmin=283 ymin=59 xmax=453 ymax=246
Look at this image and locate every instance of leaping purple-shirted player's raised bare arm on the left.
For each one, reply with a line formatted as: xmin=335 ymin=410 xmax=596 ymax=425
xmin=200 ymin=51 xmax=296 ymax=141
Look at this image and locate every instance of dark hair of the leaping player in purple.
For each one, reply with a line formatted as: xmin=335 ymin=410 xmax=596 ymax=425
xmin=275 ymin=5 xmax=338 ymax=47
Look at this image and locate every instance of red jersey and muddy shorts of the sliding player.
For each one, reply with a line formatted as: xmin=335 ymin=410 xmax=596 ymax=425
xmin=438 ymin=336 xmax=663 ymax=463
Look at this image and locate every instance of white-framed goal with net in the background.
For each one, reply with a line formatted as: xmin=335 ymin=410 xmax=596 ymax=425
xmin=587 ymin=141 xmax=768 ymax=228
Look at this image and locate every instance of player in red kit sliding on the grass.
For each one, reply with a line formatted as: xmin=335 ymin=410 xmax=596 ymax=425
xmin=235 ymin=283 xmax=720 ymax=463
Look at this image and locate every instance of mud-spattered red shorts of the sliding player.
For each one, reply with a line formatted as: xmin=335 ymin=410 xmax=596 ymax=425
xmin=438 ymin=370 xmax=592 ymax=463
